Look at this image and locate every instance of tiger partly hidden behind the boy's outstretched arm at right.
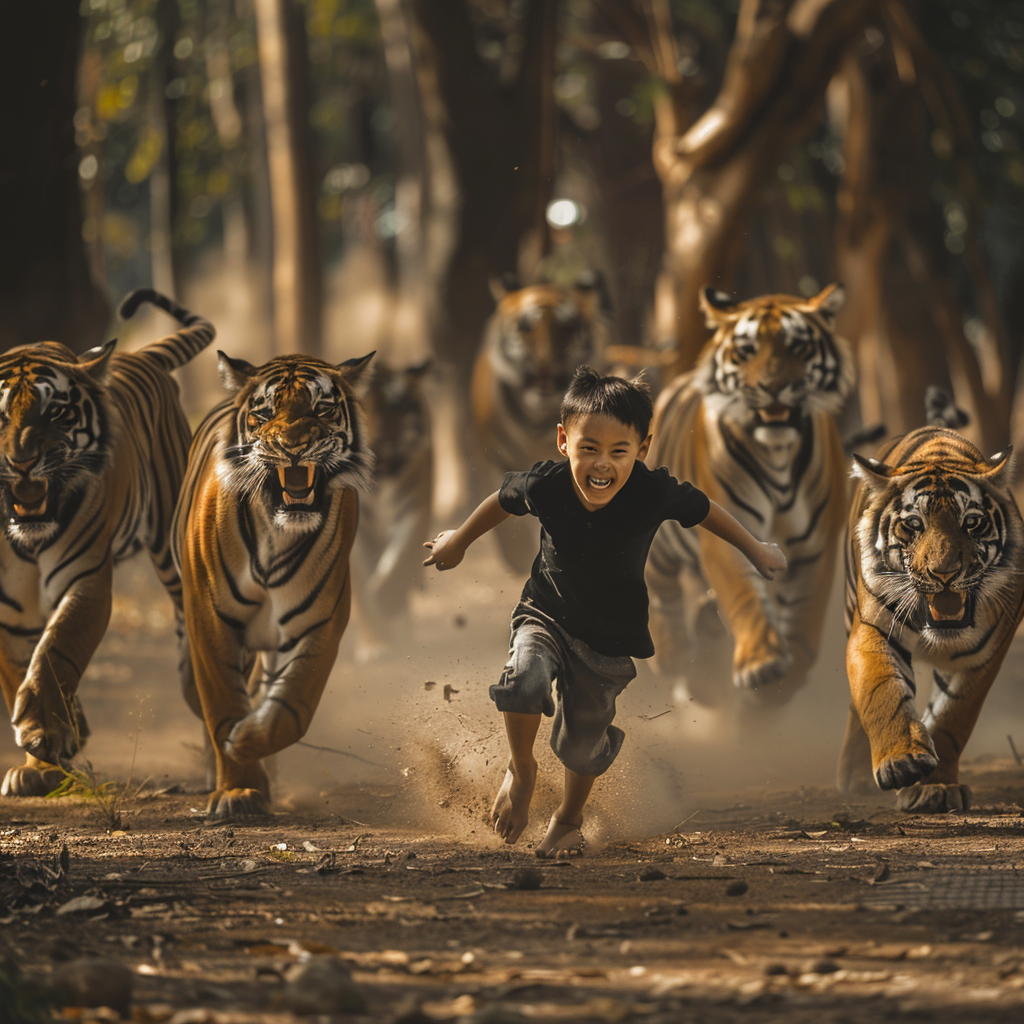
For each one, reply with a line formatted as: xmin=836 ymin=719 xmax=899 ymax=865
xmin=647 ymin=285 xmax=853 ymax=708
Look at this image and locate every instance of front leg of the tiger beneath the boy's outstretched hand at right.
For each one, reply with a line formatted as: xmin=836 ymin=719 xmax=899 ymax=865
xmin=700 ymin=532 xmax=792 ymax=690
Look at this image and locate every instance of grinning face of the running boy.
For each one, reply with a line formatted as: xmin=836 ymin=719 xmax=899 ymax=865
xmin=558 ymin=415 xmax=650 ymax=512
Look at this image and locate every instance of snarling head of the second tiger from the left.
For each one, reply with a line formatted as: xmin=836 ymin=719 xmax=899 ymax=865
xmin=217 ymin=352 xmax=374 ymax=532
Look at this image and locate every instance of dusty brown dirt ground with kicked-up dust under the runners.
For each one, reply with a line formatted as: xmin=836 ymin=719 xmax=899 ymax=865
xmin=0 ymin=543 xmax=1024 ymax=1024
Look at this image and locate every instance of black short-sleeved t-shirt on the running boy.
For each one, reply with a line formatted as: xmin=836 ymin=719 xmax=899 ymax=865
xmin=498 ymin=461 xmax=711 ymax=657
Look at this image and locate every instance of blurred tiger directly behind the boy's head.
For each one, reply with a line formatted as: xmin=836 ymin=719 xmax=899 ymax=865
xmin=470 ymin=273 xmax=610 ymax=572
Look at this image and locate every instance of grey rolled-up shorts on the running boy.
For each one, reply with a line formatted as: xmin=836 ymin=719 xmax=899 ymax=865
xmin=490 ymin=603 xmax=637 ymax=775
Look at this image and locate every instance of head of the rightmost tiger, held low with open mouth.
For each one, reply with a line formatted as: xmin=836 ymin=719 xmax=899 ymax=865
xmin=853 ymin=427 xmax=1024 ymax=646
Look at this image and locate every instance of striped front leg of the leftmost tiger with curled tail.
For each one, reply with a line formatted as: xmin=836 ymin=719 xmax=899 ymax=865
xmin=0 ymin=556 xmax=113 ymax=796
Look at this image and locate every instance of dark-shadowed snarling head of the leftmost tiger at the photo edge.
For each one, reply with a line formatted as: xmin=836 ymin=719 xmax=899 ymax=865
xmin=0 ymin=341 xmax=117 ymax=545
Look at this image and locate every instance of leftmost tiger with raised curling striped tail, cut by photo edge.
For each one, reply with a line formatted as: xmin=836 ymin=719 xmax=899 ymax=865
xmin=0 ymin=289 xmax=215 ymax=797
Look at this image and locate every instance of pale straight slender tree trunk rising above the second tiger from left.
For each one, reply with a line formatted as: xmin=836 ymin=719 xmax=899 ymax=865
xmin=253 ymin=0 xmax=323 ymax=355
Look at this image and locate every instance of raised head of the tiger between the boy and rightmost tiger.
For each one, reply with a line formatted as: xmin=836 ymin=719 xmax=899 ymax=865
xmin=699 ymin=285 xmax=853 ymax=445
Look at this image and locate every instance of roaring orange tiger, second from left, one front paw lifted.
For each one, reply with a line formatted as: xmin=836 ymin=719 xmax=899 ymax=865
xmin=171 ymin=352 xmax=374 ymax=819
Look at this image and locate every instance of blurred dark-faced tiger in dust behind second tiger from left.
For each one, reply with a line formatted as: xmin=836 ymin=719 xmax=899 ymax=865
xmin=352 ymin=359 xmax=434 ymax=660
